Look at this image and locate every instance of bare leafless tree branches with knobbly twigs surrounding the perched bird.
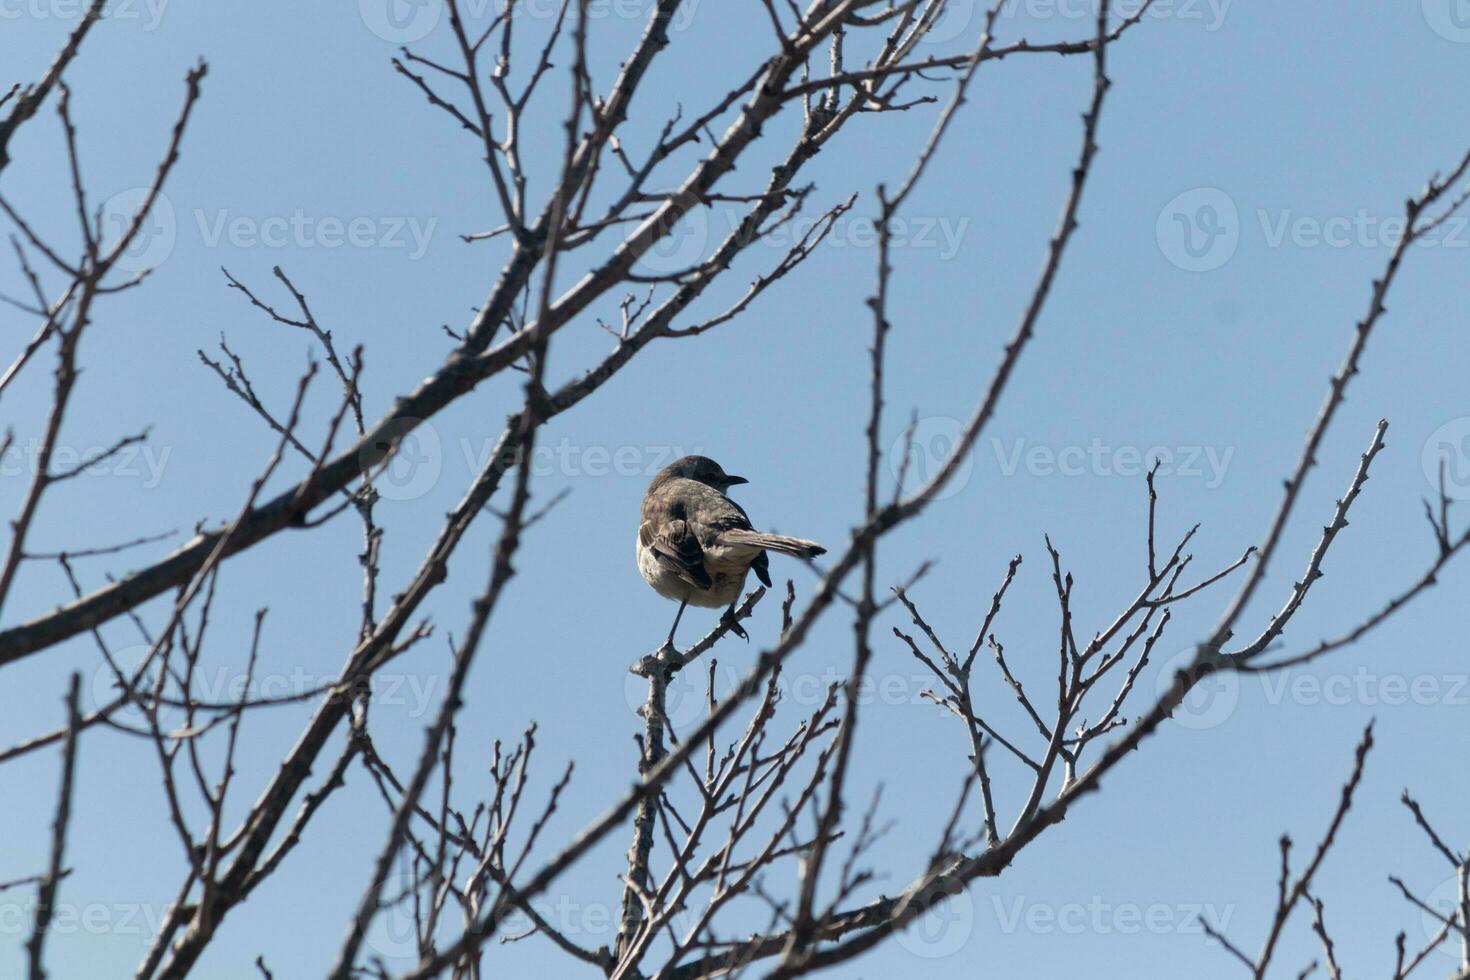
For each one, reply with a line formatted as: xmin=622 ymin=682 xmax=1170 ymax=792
xmin=0 ymin=0 xmax=1470 ymax=980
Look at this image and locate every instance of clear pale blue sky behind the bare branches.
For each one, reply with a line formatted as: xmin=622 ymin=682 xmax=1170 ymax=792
xmin=0 ymin=0 xmax=1470 ymax=980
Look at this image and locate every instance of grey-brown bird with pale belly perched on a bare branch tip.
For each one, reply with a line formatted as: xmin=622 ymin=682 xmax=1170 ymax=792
xmin=638 ymin=455 xmax=826 ymax=646
